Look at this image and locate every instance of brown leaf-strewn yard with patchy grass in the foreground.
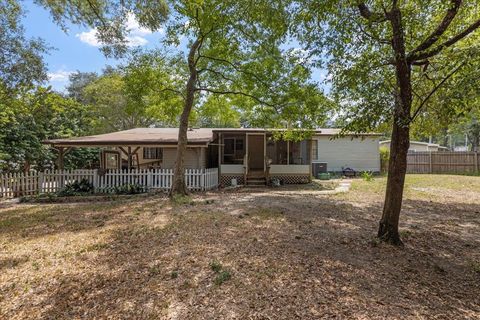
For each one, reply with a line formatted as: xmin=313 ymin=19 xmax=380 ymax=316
xmin=0 ymin=175 xmax=480 ymax=320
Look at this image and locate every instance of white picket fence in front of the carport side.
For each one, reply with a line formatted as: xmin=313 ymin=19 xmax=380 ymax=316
xmin=0 ymin=168 xmax=218 ymax=198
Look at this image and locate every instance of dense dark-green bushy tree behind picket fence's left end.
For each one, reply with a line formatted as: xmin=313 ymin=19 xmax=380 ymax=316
xmin=0 ymin=87 xmax=92 ymax=171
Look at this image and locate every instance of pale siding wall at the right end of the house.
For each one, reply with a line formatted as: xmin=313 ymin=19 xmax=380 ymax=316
xmin=312 ymin=136 xmax=380 ymax=172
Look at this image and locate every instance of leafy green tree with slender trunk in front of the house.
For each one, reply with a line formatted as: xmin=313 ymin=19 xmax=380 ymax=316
xmin=159 ymin=0 xmax=304 ymax=195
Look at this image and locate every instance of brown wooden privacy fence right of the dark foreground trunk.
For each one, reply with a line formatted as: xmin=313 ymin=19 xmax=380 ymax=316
xmin=407 ymin=151 xmax=480 ymax=174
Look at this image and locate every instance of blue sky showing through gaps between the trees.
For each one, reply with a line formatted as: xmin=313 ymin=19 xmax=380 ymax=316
xmin=23 ymin=0 xmax=329 ymax=91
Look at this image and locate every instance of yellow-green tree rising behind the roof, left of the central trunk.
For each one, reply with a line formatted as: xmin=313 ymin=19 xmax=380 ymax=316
xmin=80 ymin=50 xmax=181 ymax=133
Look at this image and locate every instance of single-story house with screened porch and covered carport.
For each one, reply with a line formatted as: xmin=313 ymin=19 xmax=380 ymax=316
xmin=45 ymin=128 xmax=380 ymax=185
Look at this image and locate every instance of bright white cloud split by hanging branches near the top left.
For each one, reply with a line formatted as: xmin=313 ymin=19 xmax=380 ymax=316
xmin=75 ymin=14 xmax=159 ymax=47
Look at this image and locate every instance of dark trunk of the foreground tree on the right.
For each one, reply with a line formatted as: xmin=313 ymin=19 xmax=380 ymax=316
xmin=378 ymin=8 xmax=412 ymax=245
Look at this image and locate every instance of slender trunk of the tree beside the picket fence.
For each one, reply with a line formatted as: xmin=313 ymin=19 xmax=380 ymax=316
xmin=169 ymin=39 xmax=201 ymax=197
